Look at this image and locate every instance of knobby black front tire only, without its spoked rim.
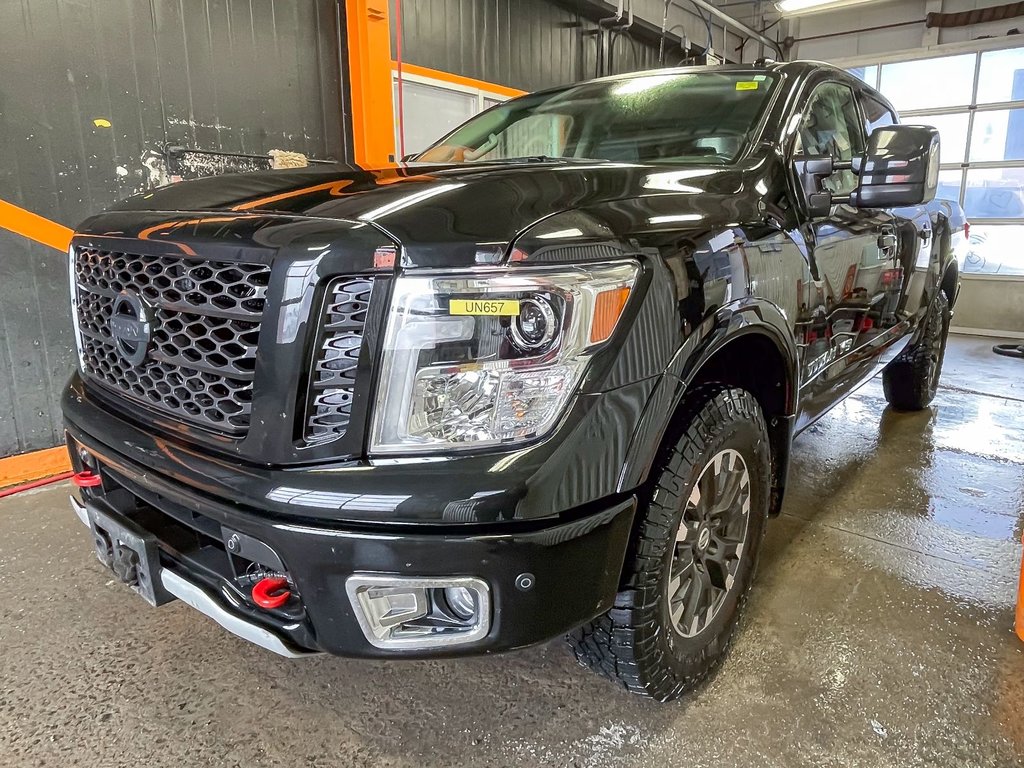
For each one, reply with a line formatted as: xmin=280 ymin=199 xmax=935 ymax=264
xmin=568 ymin=384 xmax=771 ymax=701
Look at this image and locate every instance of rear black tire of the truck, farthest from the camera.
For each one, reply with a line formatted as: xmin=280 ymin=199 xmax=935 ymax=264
xmin=882 ymin=291 xmax=949 ymax=411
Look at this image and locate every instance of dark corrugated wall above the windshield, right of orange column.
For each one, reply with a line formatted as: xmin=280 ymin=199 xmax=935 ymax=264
xmin=390 ymin=0 xmax=660 ymax=91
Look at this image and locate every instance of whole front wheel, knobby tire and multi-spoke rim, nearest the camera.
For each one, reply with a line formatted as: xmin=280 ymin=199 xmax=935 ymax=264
xmin=569 ymin=385 xmax=770 ymax=701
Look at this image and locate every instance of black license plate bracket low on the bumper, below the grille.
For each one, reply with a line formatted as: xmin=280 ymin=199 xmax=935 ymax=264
xmin=86 ymin=504 xmax=174 ymax=605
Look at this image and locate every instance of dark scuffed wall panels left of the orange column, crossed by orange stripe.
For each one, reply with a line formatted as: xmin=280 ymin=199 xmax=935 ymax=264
xmin=0 ymin=0 xmax=347 ymax=457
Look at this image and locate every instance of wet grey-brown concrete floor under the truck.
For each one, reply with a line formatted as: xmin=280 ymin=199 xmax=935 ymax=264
xmin=0 ymin=338 xmax=1024 ymax=768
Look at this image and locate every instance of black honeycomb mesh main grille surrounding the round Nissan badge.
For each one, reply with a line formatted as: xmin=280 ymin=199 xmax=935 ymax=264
xmin=75 ymin=248 xmax=270 ymax=435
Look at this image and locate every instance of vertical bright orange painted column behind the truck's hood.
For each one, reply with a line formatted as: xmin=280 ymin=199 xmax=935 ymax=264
xmin=345 ymin=0 xmax=395 ymax=168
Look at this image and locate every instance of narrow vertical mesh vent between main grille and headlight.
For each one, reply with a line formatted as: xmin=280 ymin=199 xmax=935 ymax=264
xmin=305 ymin=278 xmax=373 ymax=443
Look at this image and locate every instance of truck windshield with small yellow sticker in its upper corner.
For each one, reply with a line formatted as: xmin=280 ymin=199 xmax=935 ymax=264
xmin=415 ymin=72 xmax=774 ymax=164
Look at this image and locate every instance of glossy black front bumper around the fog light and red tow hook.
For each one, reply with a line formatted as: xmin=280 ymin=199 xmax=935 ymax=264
xmin=69 ymin=434 xmax=635 ymax=657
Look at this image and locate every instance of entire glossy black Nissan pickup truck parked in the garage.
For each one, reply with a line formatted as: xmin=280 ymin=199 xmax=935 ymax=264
xmin=63 ymin=62 xmax=966 ymax=700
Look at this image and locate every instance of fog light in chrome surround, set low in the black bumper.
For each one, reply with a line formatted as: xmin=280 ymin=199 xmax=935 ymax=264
xmin=345 ymin=573 xmax=490 ymax=650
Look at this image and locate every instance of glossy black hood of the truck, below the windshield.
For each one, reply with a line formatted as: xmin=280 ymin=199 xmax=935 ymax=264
xmin=94 ymin=161 xmax=742 ymax=266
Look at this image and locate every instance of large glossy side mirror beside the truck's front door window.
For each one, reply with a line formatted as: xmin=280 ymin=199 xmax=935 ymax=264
xmin=850 ymin=125 xmax=939 ymax=208
